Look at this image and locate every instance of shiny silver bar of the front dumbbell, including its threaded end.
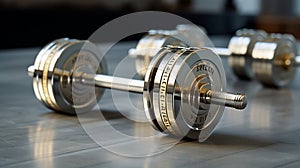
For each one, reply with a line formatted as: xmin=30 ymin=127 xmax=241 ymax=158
xmin=28 ymin=65 xmax=247 ymax=109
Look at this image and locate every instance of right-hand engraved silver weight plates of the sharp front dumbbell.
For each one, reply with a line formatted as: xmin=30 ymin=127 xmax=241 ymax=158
xmin=143 ymin=47 xmax=231 ymax=141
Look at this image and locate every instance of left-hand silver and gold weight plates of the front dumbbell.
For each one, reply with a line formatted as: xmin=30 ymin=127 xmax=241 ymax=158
xmin=28 ymin=39 xmax=106 ymax=114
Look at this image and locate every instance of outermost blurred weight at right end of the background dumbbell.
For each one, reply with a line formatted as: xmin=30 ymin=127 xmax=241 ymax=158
xmin=251 ymin=34 xmax=297 ymax=87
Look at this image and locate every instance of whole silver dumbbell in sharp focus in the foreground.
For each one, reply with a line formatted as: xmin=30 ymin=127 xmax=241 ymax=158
xmin=28 ymin=39 xmax=247 ymax=139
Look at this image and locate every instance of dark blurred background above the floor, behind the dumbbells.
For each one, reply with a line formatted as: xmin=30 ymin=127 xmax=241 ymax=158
xmin=0 ymin=0 xmax=300 ymax=49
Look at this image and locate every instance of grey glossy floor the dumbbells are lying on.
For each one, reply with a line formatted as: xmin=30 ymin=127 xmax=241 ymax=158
xmin=0 ymin=38 xmax=300 ymax=168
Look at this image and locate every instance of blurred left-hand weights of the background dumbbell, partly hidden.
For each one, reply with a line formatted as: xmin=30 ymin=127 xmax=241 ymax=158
xmin=128 ymin=24 xmax=212 ymax=78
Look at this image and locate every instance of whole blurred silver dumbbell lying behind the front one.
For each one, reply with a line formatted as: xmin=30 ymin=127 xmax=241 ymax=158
xmin=129 ymin=25 xmax=300 ymax=87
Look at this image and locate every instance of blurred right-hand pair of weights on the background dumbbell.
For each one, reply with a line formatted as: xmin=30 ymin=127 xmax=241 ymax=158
xmin=224 ymin=30 xmax=300 ymax=88
